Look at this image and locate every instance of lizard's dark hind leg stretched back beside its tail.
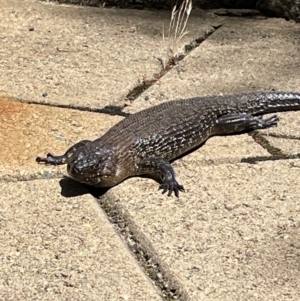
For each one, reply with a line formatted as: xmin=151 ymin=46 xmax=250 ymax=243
xmin=215 ymin=113 xmax=279 ymax=134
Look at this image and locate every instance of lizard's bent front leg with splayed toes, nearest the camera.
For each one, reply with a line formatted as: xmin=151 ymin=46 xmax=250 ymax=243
xmin=138 ymin=157 xmax=184 ymax=197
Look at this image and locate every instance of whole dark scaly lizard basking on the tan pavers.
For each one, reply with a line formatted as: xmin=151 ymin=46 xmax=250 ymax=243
xmin=36 ymin=92 xmax=300 ymax=197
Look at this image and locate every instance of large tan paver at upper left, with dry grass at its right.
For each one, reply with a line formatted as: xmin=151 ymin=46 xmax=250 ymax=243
xmin=0 ymin=0 xmax=220 ymax=107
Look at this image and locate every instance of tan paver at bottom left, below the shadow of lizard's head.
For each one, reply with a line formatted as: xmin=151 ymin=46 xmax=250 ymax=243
xmin=0 ymin=180 xmax=161 ymax=301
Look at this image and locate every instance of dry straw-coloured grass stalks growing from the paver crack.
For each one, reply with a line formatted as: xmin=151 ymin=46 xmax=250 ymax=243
xmin=159 ymin=0 xmax=193 ymax=73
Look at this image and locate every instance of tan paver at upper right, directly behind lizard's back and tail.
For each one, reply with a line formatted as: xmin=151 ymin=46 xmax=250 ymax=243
xmin=124 ymin=18 xmax=300 ymax=113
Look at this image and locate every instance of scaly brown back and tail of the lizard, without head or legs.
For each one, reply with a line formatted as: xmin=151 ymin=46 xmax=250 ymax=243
xmin=96 ymin=92 xmax=300 ymax=160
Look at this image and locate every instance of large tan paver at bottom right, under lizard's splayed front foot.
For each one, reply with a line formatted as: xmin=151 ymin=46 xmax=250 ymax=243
xmin=110 ymin=162 xmax=300 ymax=301
